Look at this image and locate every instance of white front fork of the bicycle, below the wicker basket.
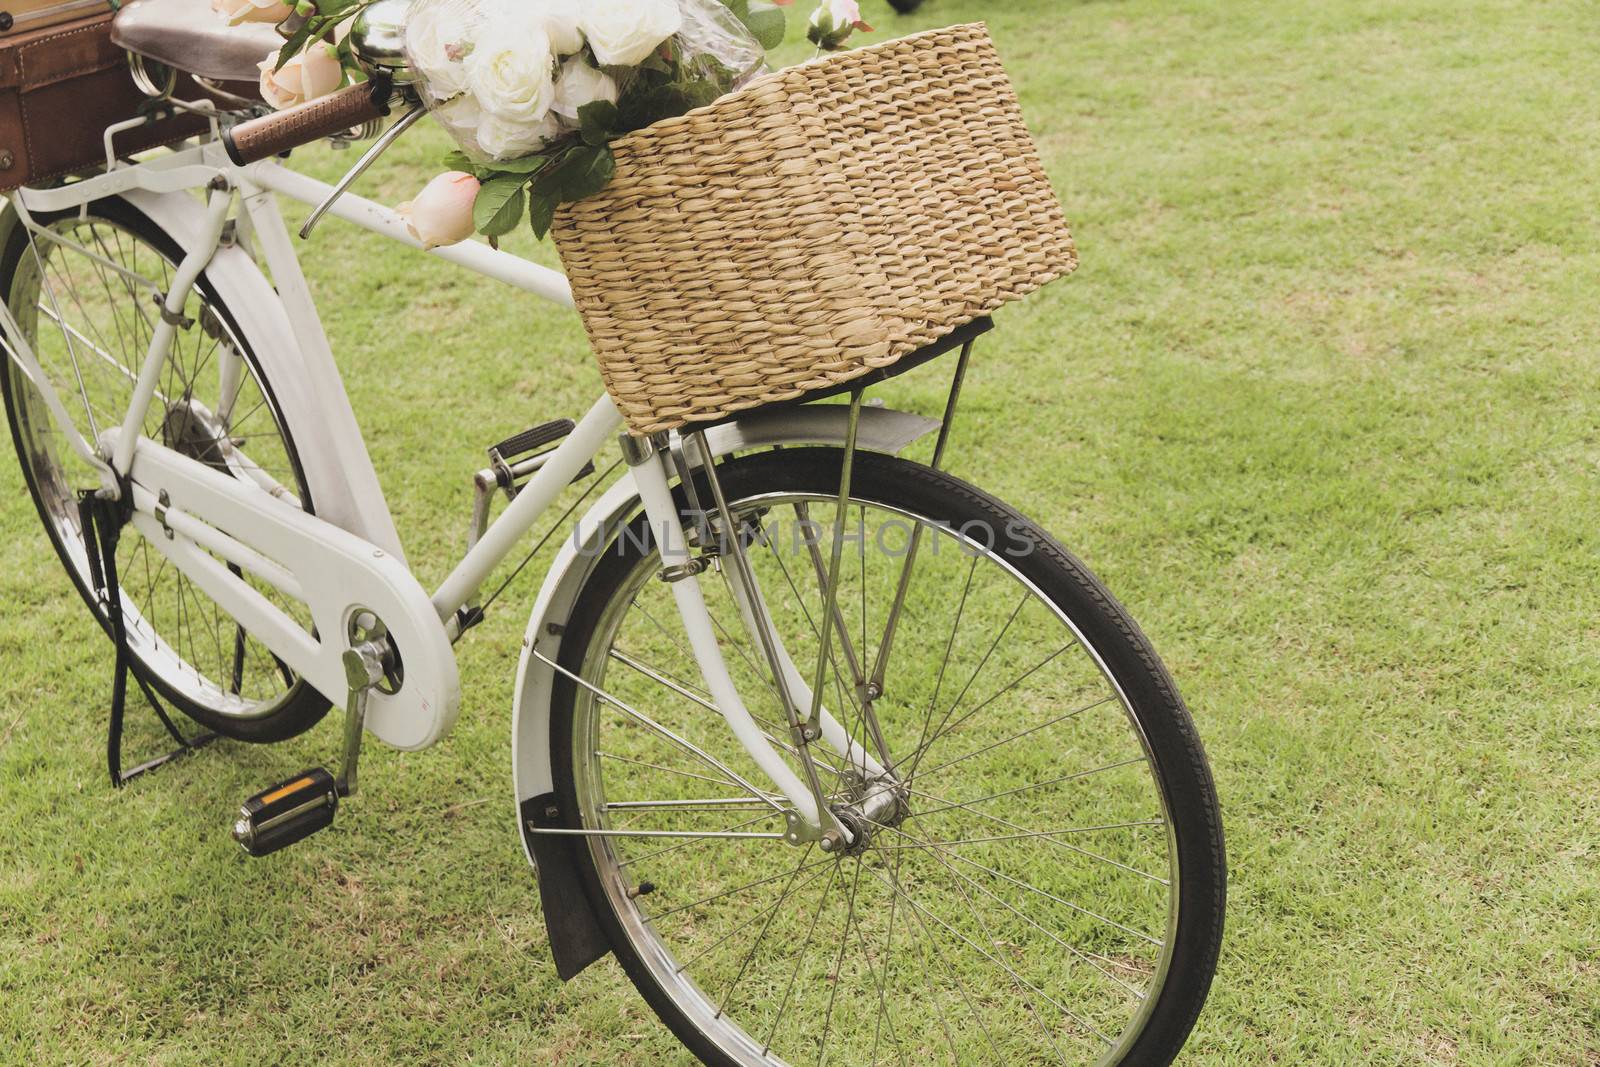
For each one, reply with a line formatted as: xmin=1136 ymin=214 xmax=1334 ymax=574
xmin=622 ymin=435 xmax=888 ymax=851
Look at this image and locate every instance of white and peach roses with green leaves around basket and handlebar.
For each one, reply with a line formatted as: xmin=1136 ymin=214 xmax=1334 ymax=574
xmin=232 ymin=0 xmax=870 ymax=246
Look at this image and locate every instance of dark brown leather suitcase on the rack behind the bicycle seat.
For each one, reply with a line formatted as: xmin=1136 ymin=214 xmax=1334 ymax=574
xmin=0 ymin=10 xmax=206 ymax=190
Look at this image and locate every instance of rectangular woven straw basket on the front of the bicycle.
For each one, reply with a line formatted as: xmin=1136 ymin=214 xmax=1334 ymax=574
xmin=552 ymin=24 xmax=1077 ymax=434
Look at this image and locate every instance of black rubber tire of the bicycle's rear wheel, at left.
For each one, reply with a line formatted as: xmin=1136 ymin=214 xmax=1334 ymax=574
xmin=0 ymin=197 xmax=330 ymax=744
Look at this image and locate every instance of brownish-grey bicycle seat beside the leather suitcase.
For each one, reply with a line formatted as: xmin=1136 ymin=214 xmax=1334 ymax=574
xmin=110 ymin=0 xmax=283 ymax=83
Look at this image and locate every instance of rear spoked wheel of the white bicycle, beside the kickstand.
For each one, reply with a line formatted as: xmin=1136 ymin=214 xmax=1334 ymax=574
xmin=0 ymin=198 xmax=328 ymax=741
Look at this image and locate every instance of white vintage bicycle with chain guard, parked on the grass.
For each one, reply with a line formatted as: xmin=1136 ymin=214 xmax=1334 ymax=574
xmin=0 ymin=0 xmax=1224 ymax=1064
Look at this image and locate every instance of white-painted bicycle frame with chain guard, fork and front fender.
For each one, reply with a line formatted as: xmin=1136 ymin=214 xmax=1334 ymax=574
xmin=0 ymin=131 xmax=915 ymax=840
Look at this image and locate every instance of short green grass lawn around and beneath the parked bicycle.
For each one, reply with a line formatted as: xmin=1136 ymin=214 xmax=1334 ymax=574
xmin=0 ymin=0 xmax=1600 ymax=1067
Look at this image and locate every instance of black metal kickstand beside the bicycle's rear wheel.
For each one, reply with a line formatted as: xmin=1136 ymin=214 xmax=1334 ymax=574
xmin=78 ymin=482 xmax=218 ymax=789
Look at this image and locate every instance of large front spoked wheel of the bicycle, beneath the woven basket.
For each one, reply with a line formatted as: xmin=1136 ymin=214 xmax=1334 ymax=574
xmin=552 ymin=450 xmax=1226 ymax=1065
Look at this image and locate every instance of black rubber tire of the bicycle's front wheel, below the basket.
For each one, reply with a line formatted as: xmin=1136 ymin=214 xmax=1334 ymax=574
xmin=550 ymin=448 xmax=1226 ymax=1067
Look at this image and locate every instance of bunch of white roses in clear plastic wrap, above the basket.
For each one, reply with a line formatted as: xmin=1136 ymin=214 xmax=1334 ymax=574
xmin=406 ymin=0 xmax=766 ymax=166
